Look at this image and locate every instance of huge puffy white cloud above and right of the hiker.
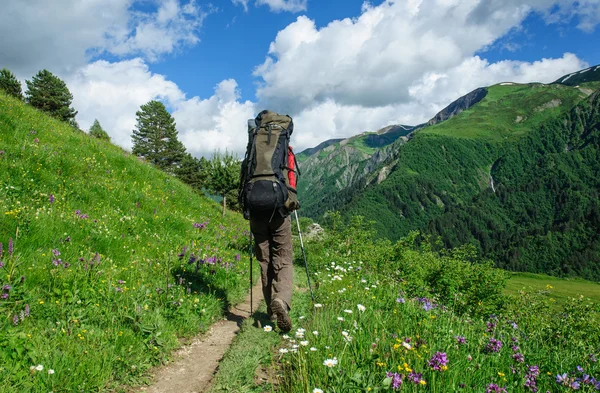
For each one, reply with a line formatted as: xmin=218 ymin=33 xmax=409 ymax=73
xmin=254 ymin=0 xmax=600 ymax=113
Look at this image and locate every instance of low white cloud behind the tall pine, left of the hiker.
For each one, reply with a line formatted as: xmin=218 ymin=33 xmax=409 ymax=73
xmin=66 ymin=58 xmax=255 ymax=157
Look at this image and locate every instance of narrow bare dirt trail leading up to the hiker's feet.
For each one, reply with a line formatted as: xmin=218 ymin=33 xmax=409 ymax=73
xmin=135 ymin=285 xmax=262 ymax=393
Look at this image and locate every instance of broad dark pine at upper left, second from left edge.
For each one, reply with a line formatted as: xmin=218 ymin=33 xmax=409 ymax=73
xmin=25 ymin=70 xmax=77 ymax=121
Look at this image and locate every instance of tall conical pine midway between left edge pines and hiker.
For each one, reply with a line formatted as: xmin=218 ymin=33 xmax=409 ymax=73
xmin=132 ymin=100 xmax=185 ymax=173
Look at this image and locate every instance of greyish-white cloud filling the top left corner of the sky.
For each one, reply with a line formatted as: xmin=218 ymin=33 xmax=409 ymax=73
xmin=0 ymin=0 xmax=210 ymax=78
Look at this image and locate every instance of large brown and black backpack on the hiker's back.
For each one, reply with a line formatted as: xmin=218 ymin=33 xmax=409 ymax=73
xmin=239 ymin=110 xmax=300 ymax=219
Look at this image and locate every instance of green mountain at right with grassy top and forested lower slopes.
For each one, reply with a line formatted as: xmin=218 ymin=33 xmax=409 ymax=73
xmin=331 ymin=82 xmax=600 ymax=280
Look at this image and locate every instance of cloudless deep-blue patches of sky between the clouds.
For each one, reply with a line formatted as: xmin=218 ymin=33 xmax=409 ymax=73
xmin=151 ymin=0 xmax=600 ymax=101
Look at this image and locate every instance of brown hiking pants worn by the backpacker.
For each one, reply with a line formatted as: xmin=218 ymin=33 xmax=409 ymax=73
xmin=250 ymin=213 xmax=293 ymax=310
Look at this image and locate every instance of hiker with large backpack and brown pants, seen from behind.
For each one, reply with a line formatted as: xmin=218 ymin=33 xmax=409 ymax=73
xmin=239 ymin=110 xmax=300 ymax=332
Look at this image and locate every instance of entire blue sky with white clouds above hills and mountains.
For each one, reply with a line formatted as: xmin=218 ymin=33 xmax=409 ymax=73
xmin=0 ymin=0 xmax=600 ymax=156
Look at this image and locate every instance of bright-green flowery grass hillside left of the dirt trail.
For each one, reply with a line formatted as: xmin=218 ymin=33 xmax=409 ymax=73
xmin=0 ymin=94 xmax=248 ymax=392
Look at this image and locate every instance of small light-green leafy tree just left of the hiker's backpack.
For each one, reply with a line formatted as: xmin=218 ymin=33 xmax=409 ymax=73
xmin=207 ymin=151 xmax=241 ymax=215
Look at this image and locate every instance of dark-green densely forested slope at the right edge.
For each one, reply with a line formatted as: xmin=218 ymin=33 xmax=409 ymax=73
xmin=427 ymin=90 xmax=600 ymax=281
